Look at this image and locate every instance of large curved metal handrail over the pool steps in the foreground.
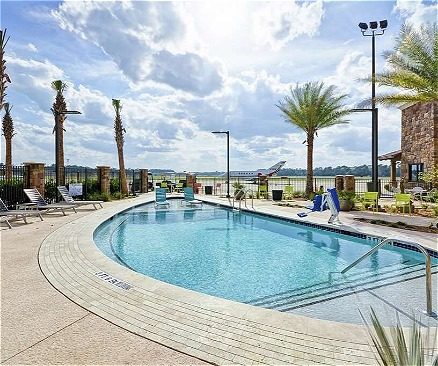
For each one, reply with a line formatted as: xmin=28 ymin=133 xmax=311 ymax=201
xmin=341 ymin=238 xmax=436 ymax=317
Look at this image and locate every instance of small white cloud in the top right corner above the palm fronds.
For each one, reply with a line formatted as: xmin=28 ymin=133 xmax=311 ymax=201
xmin=394 ymin=0 xmax=438 ymax=27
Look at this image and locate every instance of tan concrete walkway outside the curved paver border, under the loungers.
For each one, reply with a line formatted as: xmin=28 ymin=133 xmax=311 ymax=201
xmin=0 ymin=202 xmax=205 ymax=365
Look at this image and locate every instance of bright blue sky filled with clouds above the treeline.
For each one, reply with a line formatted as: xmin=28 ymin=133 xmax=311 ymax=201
xmin=0 ymin=0 xmax=437 ymax=171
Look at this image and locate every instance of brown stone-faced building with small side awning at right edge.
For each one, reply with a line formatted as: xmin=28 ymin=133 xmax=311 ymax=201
xmin=379 ymin=102 xmax=438 ymax=185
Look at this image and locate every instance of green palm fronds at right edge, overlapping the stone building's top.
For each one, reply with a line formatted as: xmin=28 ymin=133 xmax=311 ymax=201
xmin=376 ymin=23 xmax=438 ymax=104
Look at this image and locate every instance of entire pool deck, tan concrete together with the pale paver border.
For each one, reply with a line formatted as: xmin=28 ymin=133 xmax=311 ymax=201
xmin=1 ymin=194 xmax=436 ymax=364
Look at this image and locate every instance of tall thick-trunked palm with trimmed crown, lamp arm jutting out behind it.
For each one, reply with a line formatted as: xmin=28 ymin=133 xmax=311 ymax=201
xmin=51 ymin=80 xmax=67 ymax=186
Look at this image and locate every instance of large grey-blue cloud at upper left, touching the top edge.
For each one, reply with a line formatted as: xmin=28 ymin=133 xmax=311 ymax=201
xmin=53 ymin=1 xmax=222 ymax=95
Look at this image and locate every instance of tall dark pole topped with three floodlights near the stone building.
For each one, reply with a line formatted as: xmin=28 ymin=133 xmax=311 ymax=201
xmin=353 ymin=19 xmax=388 ymax=192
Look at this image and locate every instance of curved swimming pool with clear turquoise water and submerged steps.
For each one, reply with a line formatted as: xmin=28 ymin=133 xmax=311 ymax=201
xmin=94 ymin=200 xmax=437 ymax=323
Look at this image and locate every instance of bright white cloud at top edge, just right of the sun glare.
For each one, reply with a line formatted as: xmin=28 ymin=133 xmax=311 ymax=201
xmin=253 ymin=0 xmax=324 ymax=50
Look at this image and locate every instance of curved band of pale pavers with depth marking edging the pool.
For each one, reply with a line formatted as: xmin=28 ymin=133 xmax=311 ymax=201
xmin=39 ymin=195 xmax=434 ymax=364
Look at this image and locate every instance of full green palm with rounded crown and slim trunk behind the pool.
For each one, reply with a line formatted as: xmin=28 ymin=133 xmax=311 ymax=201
xmin=277 ymin=82 xmax=350 ymax=196
